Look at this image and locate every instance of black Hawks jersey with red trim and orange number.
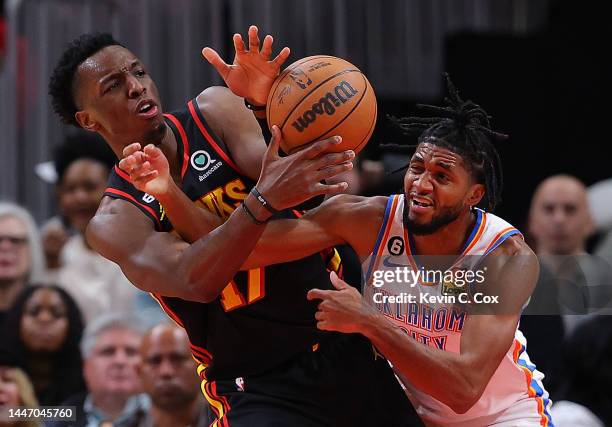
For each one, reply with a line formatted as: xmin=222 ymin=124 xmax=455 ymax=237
xmin=104 ymin=100 xmax=341 ymax=379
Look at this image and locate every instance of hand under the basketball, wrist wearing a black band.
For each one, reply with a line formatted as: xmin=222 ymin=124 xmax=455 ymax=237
xmin=256 ymin=125 xmax=355 ymax=210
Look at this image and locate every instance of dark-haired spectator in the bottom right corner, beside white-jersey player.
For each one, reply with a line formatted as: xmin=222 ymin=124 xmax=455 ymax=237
xmin=552 ymin=316 xmax=612 ymax=427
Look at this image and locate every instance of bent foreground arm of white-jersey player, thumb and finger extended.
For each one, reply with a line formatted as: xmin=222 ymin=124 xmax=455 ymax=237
xmin=308 ymin=237 xmax=539 ymax=413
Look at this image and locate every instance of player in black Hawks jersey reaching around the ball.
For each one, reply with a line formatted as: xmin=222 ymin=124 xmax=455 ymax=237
xmin=50 ymin=27 xmax=420 ymax=426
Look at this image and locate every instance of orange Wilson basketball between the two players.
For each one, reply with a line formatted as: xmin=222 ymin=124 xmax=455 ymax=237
xmin=266 ymin=55 xmax=377 ymax=153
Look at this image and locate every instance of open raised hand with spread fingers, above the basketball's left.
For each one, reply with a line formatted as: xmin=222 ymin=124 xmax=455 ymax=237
xmin=202 ymin=25 xmax=289 ymax=105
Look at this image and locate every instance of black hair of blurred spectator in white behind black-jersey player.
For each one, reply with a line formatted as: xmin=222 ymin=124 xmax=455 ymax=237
xmin=53 ymin=130 xmax=117 ymax=184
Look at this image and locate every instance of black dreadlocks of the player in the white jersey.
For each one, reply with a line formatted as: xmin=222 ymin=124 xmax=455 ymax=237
xmin=383 ymin=73 xmax=508 ymax=211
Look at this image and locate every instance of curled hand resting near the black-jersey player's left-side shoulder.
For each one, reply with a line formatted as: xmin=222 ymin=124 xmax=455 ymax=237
xmin=119 ymin=142 xmax=172 ymax=198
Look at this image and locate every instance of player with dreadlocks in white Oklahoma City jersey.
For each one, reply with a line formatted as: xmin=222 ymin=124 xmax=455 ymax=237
xmin=130 ymin=75 xmax=552 ymax=427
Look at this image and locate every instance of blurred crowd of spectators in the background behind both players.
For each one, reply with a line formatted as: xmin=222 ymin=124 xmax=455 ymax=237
xmin=0 ymin=129 xmax=612 ymax=426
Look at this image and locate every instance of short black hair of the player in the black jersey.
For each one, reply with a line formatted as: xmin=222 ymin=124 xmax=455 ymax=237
xmin=49 ymin=33 xmax=122 ymax=127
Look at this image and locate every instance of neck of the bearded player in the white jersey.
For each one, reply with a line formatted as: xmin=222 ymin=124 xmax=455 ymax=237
xmin=412 ymin=210 xmax=476 ymax=255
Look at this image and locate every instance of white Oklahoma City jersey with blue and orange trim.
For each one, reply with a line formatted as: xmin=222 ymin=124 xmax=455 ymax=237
xmin=362 ymin=195 xmax=553 ymax=427
